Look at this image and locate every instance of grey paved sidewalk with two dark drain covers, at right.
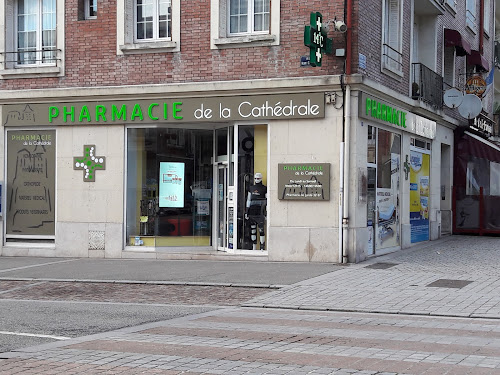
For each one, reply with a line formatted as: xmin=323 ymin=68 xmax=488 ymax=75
xmin=245 ymin=236 xmax=500 ymax=319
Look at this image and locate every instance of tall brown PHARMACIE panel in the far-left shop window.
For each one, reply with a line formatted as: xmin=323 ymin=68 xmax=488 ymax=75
xmin=6 ymin=130 xmax=56 ymax=236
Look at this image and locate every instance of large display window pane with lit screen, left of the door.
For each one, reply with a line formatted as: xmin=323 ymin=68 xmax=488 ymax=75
xmin=127 ymin=128 xmax=213 ymax=246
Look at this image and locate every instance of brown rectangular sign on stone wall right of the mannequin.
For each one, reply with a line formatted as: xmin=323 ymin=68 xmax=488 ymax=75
xmin=278 ymin=163 xmax=330 ymax=201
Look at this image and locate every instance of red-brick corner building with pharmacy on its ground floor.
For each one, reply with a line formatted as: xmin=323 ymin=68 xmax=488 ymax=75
xmin=0 ymin=0 xmax=494 ymax=262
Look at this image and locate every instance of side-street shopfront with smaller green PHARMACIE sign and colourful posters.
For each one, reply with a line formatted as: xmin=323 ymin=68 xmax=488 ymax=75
xmin=358 ymin=93 xmax=442 ymax=256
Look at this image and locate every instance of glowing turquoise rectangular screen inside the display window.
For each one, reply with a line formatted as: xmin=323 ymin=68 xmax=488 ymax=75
xmin=158 ymin=162 xmax=184 ymax=208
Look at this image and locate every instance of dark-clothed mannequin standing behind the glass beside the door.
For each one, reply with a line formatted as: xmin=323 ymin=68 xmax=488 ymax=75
xmin=245 ymin=172 xmax=267 ymax=250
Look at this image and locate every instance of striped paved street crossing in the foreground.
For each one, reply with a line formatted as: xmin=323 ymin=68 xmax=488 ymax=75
xmin=0 ymin=308 xmax=500 ymax=375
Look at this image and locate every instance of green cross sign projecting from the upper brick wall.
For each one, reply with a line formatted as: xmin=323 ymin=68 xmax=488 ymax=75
xmin=304 ymin=12 xmax=333 ymax=66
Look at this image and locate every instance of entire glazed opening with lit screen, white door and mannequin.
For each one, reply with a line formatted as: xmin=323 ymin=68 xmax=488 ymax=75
xmin=126 ymin=125 xmax=267 ymax=251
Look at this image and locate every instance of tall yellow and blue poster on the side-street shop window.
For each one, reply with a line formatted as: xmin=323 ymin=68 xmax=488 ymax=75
xmin=410 ymin=151 xmax=430 ymax=243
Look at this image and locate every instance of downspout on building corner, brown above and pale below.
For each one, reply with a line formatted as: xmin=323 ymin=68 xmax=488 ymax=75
xmin=339 ymin=0 xmax=354 ymax=263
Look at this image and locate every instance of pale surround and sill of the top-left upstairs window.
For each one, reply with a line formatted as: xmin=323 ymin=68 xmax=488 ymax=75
xmin=0 ymin=0 xmax=65 ymax=79
